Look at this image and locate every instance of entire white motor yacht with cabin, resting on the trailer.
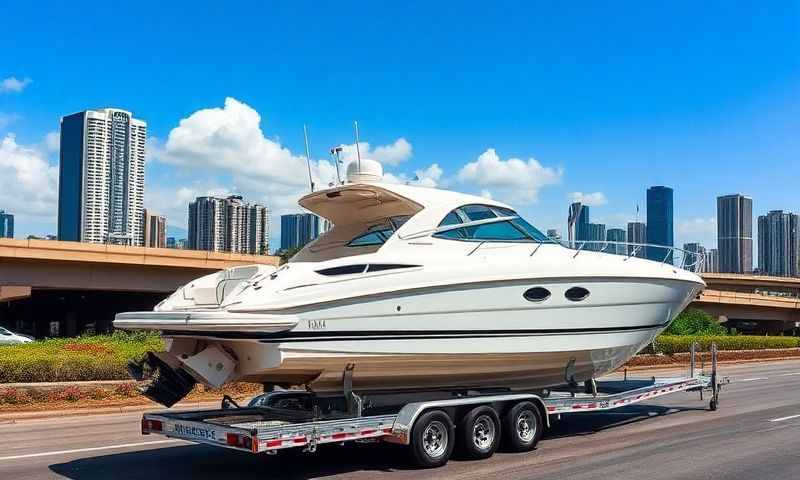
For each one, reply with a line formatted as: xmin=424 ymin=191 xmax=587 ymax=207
xmin=114 ymin=159 xmax=705 ymax=406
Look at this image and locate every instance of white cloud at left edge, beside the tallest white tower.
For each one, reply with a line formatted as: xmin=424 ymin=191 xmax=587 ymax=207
xmin=0 ymin=134 xmax=58 ymax=222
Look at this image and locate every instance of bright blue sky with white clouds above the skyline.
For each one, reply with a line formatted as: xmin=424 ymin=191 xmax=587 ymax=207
xmin=0 ymin=1 xmax=800 ymax=251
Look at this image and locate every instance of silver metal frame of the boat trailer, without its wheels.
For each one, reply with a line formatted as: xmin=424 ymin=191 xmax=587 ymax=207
xmin=142 ymin=344 xmax=729 ymax=461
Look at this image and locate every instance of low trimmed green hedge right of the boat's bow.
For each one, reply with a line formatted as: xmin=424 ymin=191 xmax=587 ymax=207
xmin=645 ymin=335 xmax=800 ymax=355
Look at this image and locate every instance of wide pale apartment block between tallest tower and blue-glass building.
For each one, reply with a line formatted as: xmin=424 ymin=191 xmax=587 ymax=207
xmin=187 ymin=195 xmax=269 ymax=255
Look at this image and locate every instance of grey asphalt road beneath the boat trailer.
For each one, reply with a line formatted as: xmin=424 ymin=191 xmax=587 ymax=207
xmin=0 ymin=361 xmax=800 ymax=480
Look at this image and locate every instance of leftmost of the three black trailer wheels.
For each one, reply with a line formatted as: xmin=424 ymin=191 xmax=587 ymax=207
xmin=409 ymin=410 xmax=455 ymax=468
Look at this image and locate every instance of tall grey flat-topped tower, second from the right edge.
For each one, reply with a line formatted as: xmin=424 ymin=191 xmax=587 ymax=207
xmin=717 ymin=193 xmax=753 ymax=273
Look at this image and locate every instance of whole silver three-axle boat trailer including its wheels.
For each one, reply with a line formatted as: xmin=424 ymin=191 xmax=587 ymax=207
xmin=142 ymin=344 xmax=727 ymax=467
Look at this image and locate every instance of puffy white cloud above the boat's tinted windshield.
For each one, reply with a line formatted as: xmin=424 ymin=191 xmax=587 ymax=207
xmin=457 ymin=148 xmax=563 ymax=203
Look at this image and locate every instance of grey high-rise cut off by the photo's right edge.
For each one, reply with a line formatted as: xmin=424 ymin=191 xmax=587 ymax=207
xmin=758 ymin=210 xmax=800 ymax=277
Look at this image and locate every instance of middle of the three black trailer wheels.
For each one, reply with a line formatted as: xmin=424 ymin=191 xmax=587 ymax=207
xmin=456 ymin=406 xmax=501 ymax=460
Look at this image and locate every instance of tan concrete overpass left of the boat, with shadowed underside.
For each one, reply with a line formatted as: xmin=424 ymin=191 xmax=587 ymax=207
xmin=0 ymin=238 xmax=279 ymax=337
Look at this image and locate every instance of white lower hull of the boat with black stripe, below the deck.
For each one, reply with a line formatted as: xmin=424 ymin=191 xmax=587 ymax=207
xmin=161 ymin=279 xmax=700 ymax=391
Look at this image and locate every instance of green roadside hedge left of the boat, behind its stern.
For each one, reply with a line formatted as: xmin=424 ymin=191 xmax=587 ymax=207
xmin=0 ymin=331 xmax=164 ymax=384
